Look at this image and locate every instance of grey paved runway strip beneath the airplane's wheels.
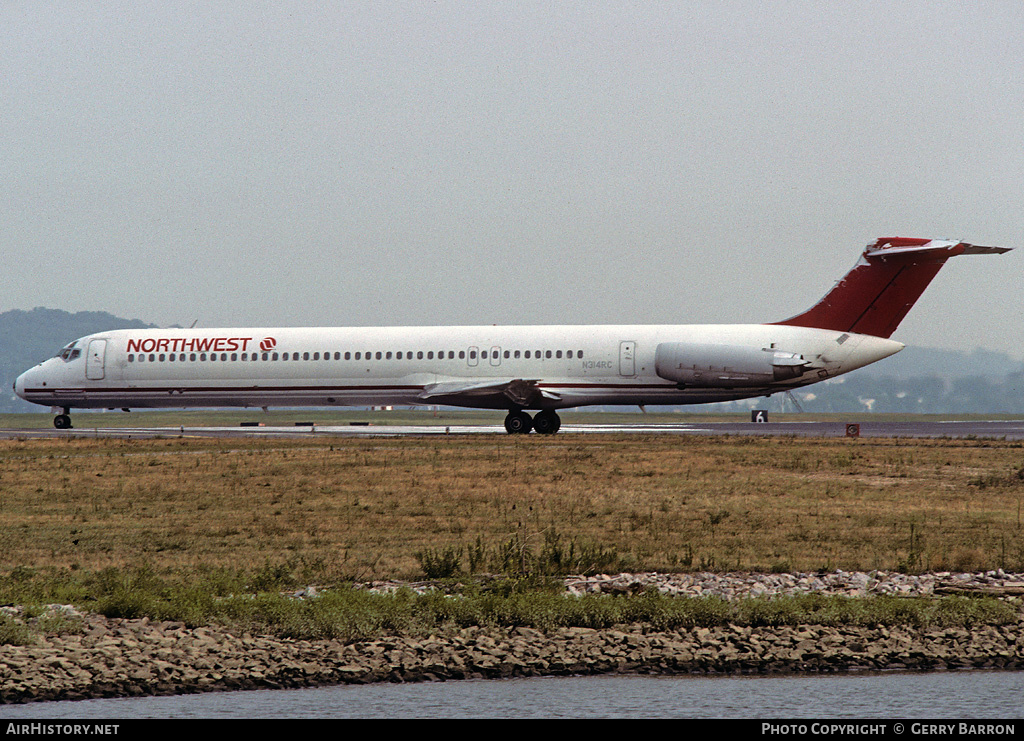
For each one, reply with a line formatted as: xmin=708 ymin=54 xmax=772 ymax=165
xmin=0 ymin=420 xmax=1024 ymax=440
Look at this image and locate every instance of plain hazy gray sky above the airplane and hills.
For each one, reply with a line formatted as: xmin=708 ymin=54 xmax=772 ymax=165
xmin=0 ymin=0 xmax=1024 ymax=358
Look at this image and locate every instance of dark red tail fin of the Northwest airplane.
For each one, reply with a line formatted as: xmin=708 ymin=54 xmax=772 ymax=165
xmin=774 ymin=236 xmax=1010 ymax=337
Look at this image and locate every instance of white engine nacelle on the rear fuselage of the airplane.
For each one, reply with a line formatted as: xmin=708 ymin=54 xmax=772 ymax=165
xmin=654 ymin=342 xmax=808 ymax=389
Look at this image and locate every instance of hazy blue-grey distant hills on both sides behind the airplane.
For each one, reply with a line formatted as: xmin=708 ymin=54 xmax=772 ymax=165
xmin=0 ymin=308 xmax=1024 ymax=413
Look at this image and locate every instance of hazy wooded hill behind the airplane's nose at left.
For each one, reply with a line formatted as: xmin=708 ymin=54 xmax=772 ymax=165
xmin=0 ymin=307 xmax=156 ymax=412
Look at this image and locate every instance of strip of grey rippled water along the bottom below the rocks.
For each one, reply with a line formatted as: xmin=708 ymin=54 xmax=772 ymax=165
xmin=0 ymin=671 xmax=1024 ymax=720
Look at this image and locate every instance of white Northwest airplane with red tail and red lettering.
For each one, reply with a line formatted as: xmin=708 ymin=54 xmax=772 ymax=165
xmin=14 ymin=237 xmax=1010 ymax=434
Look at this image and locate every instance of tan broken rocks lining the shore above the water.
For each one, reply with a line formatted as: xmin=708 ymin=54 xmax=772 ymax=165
xmin=0 ymin=572 xmax=1024 ymax=703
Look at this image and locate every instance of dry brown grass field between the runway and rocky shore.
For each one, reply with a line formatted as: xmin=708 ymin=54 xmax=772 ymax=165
xmin=0 ymin=427 xmax=1024 ymax=580
